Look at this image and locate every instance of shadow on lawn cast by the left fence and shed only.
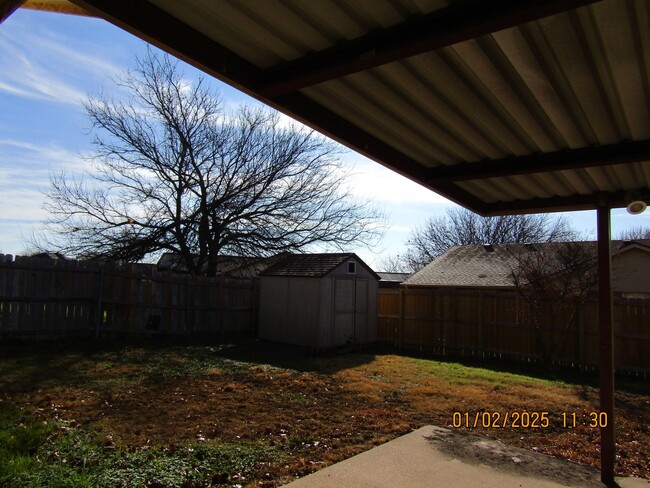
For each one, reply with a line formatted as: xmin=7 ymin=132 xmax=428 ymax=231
xmin=0 ymin=337 xmax=375 ymax=391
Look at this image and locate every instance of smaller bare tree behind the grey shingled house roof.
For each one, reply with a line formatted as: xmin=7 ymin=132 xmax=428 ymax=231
xmin=403 ymin=207 xmax=577 ymax=271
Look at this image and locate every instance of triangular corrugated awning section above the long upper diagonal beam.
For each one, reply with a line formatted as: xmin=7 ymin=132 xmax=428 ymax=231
xmin=150 ymin=0 xmax=449 ymax=68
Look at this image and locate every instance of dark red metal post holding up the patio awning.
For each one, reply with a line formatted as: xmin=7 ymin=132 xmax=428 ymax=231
xmin=597 ymin=203 xmax=616 ymax=486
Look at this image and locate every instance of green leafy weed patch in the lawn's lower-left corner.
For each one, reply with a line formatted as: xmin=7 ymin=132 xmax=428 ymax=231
xmin=0 ymin=400 xmax=284 ymax=488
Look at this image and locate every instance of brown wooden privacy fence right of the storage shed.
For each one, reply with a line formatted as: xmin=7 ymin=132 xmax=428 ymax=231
xmin=377 ymin=288 xmax=650 ymax=376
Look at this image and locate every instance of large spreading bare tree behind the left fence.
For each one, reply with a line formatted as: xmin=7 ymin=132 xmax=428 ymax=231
xmin=40 ymin=51 xmax=382 ymax=275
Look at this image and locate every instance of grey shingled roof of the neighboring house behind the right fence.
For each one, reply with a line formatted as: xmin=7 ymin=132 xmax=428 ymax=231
xmin=403 ymin=240 xmax=650 ymax=288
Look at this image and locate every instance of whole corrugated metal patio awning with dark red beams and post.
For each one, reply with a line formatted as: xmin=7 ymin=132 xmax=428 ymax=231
xmin=0 ymin=0 xmax=650 ymax=481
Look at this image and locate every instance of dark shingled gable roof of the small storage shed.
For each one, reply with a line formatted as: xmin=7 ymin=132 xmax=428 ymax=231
xmin=260 ymin=253 xmax=379 ymax=278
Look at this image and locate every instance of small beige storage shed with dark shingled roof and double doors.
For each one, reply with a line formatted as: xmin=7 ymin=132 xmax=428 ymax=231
xmin=259 ymin=253 xmax=379 ymax=348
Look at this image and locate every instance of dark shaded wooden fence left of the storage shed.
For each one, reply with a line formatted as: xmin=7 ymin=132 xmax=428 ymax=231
xmin=0 ymin=254 xmax=258 ymax=337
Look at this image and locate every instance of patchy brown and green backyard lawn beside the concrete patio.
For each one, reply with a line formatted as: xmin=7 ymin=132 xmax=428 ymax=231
xmin=0 ymin=341 xmax=650 ymax=487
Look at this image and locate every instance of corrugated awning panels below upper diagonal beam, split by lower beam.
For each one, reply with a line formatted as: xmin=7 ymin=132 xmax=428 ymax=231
xmin=294 ymin=2 xmax=650 ymax=207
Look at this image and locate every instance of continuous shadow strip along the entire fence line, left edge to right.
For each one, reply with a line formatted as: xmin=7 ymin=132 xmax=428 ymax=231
xmin=0 ymin=336 xmax=650 ymax=395
